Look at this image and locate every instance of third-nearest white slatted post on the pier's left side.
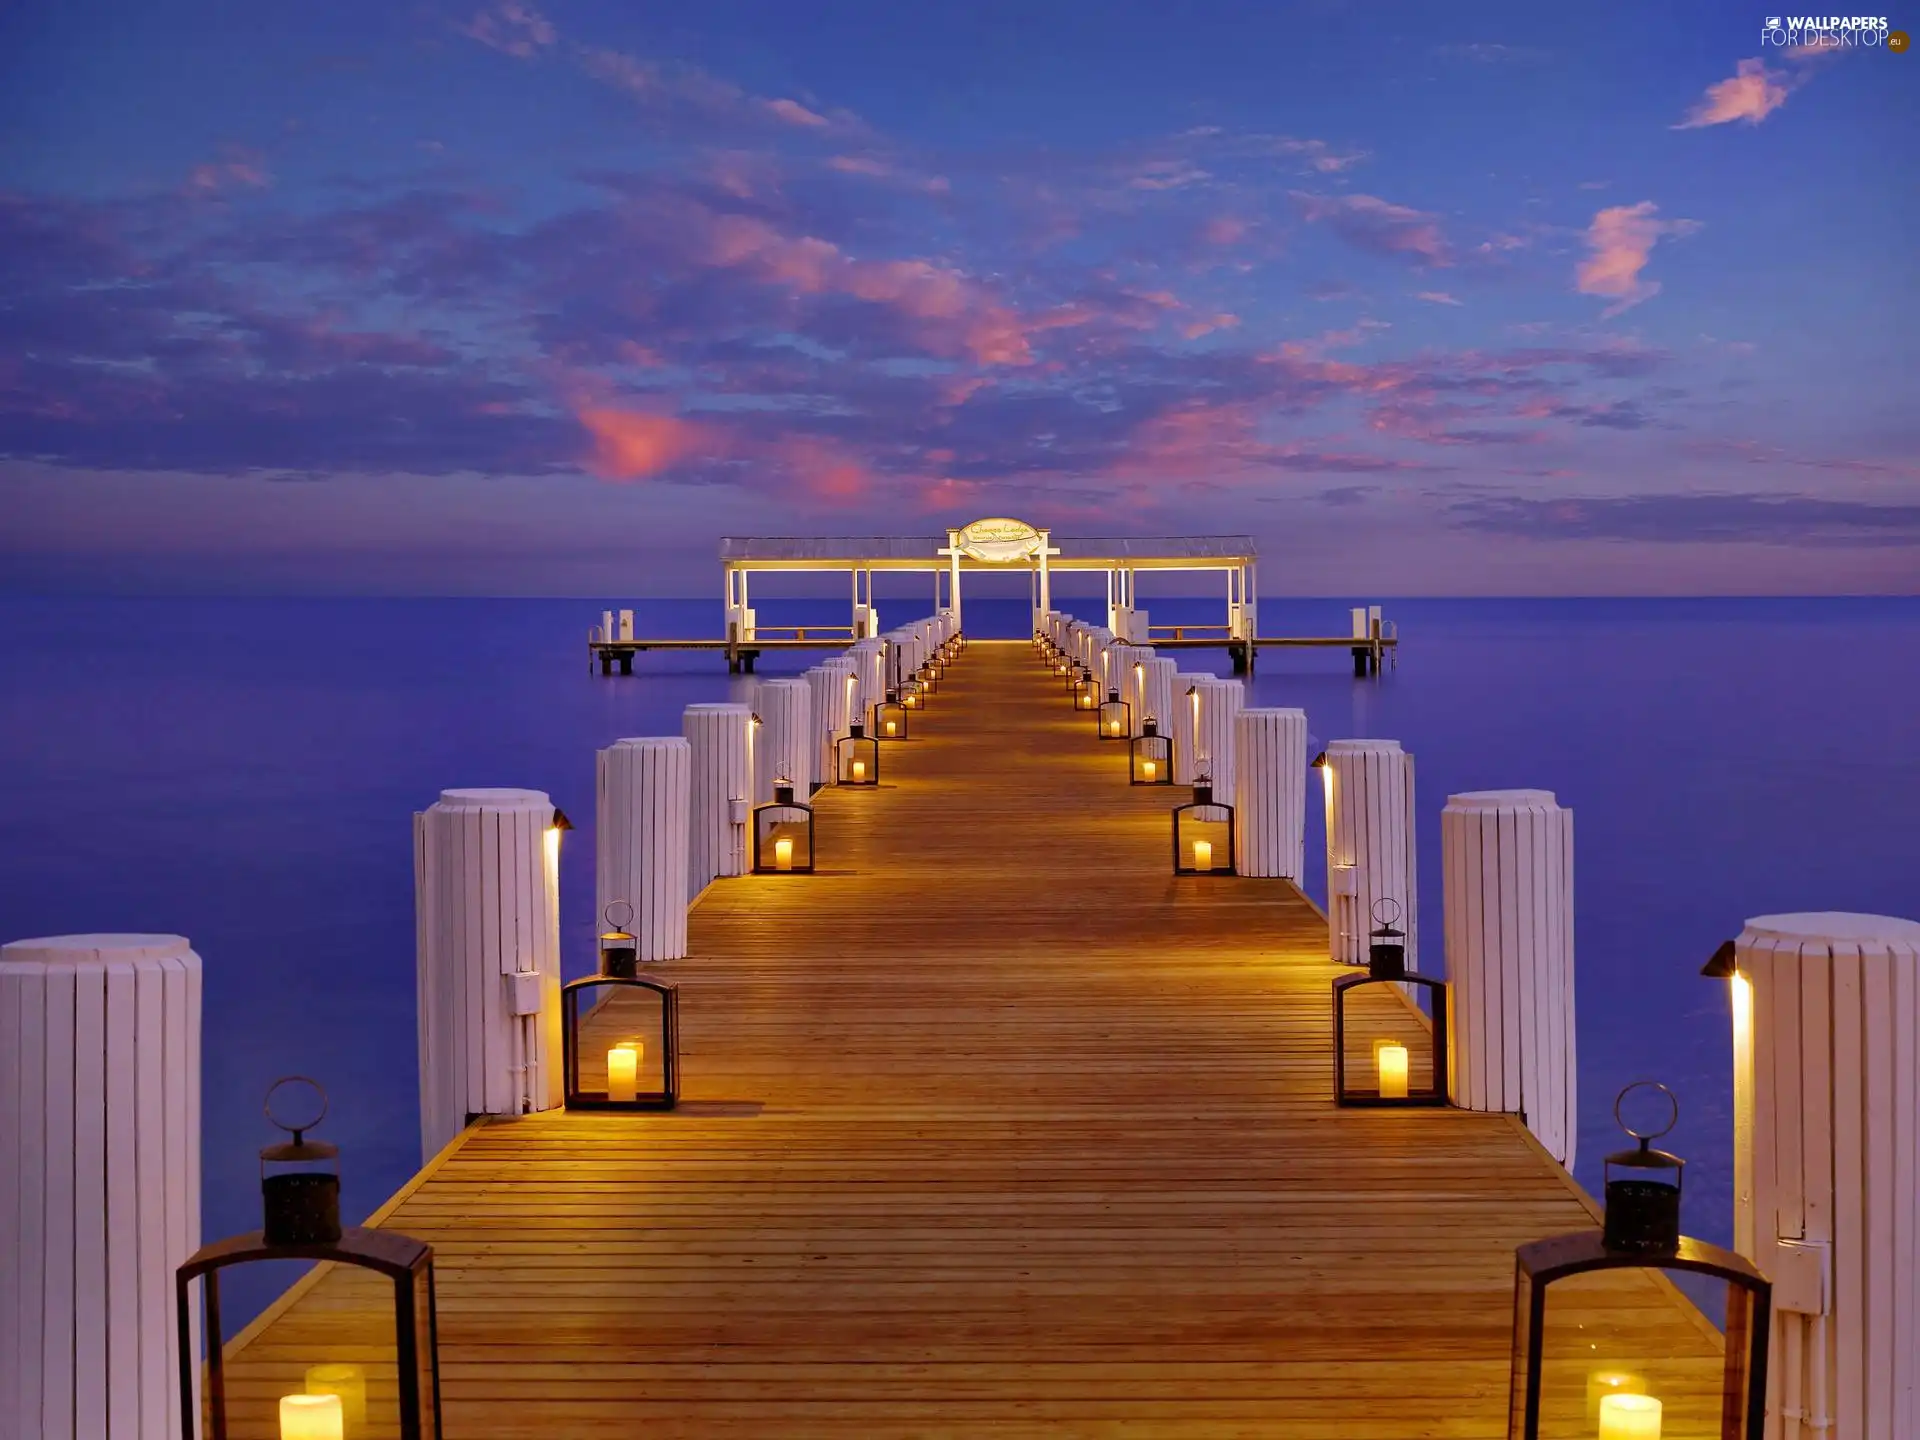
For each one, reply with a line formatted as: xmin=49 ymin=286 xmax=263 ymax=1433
xmin=593 ymin=737 xmax=698 ymax=960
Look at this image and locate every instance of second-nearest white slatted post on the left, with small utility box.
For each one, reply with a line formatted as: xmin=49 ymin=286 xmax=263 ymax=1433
xmin=413 ymin=789 xmax=561 ymax=1160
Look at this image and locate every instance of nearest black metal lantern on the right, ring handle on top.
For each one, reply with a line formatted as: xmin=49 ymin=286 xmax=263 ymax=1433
xmin=1507 ymin=1081 xmax=1772 ymax=1440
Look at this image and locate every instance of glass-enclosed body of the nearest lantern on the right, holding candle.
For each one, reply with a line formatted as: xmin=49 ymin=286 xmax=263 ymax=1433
xmin=1511 ymin=1242 xmax=1761 ymax=1440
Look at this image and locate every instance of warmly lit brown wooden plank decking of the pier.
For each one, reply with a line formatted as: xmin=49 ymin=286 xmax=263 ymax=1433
xmin=217 ymin=643 xmax=1715 ymax=1440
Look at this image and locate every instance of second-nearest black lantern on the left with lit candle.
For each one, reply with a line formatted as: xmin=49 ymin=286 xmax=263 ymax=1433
xmin=561 ymin=906 xmax=679 ymax=1110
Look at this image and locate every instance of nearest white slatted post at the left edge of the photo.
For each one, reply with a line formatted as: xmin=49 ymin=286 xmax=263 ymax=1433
xmin=0 ymin=935 xmax=200 ymax=1440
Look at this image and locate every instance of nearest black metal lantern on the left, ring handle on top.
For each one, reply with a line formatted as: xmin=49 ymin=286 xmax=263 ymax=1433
xmin=175 ymin=1075 xmax=440 ymax=1440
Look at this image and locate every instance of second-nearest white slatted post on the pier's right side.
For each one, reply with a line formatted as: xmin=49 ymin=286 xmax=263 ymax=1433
xmin=1443 ymin=789 xmax=1578 ymax=1169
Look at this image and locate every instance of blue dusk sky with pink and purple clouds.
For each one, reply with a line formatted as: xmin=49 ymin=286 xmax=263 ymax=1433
xmin=0 ymin=0 xmax=1920 ymax=597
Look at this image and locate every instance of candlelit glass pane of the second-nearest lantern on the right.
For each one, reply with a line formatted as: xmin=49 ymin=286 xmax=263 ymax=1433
xmin=1332 ymin=973 xmax=1448 ymax=1106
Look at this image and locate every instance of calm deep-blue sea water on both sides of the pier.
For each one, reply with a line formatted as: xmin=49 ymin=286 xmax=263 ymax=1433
xmin=0 ymin=595 xmax=1920 ymax=1319
